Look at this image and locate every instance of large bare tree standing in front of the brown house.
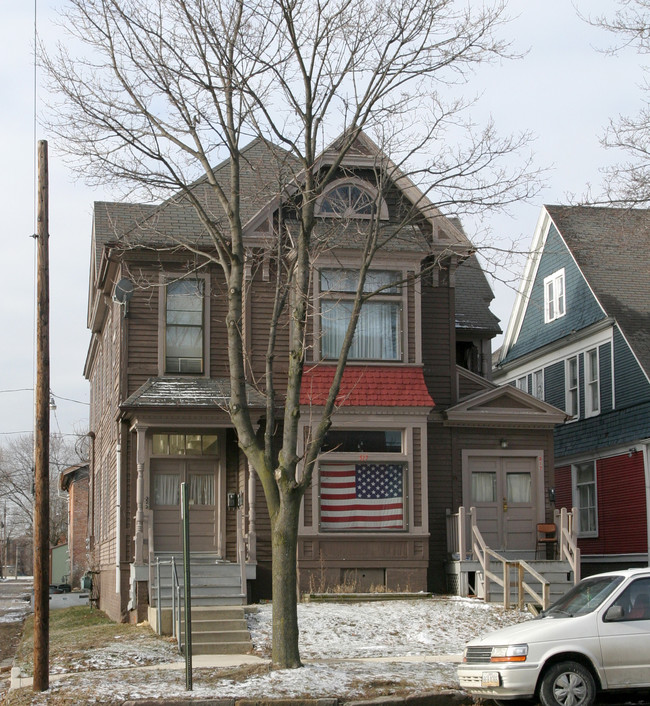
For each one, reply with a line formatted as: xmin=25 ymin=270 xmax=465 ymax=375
xmin=42 ymin=0 xmax=537 ymax=667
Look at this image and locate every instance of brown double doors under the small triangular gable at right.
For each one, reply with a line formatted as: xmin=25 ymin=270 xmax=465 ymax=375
xmin=464 ymin=456 xmax=539 ymax=550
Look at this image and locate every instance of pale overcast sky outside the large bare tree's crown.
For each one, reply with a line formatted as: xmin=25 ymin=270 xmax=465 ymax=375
xmin=0 ymin=0 xmax=642 ymax=443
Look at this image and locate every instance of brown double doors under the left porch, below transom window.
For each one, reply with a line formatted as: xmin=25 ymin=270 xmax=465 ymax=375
xmin=151 ymin=458 xmax=219 ymax=552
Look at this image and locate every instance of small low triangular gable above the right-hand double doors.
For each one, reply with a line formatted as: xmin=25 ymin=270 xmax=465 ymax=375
xmin=444 ymin=385 xmax=571 ymax=428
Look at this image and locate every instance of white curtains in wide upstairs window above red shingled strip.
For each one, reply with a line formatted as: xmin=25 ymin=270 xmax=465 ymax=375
xmin=322 ymin=302 xmax=400 ymax=360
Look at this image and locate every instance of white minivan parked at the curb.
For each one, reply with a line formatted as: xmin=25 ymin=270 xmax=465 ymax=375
xmin=458 ymin=568 xmax=650 ymax=706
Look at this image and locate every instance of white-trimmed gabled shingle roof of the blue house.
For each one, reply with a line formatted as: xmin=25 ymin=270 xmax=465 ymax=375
xmin=500 ymin=206 xmax=650 ymax=374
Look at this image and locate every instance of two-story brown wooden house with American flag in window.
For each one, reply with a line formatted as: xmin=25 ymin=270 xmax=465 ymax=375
xmin=85 ymin=131 xmax=563 ymax=622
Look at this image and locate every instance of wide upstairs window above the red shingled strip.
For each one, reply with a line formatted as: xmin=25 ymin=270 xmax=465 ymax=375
xmin=320 ymin=269 xmax=402 ymax=361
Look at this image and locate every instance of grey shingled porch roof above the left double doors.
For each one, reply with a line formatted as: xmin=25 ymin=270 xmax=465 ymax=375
xmin=121 ymin=377 xmax=266 ymax=409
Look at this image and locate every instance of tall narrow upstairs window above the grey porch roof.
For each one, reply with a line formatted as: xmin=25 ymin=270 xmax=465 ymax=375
xmin=165 ymin=279 xmax=204 ymax=373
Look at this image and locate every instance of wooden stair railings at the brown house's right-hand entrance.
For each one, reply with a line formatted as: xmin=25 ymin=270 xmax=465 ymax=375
xmin=447 ymin=506 xmax=580 ymax=609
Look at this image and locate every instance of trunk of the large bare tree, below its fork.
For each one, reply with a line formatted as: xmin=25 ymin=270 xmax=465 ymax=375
xmin=271 ymin=493 xmax=302 ymax=669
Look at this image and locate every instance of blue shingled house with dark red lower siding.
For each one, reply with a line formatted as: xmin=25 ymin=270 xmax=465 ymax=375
xmin=494 ymin=206 xmax=650 ymax=575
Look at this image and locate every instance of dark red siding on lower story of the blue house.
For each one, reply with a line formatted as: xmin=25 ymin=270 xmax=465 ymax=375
xmin=555 ymin=452 xmax=648 ymax=555
